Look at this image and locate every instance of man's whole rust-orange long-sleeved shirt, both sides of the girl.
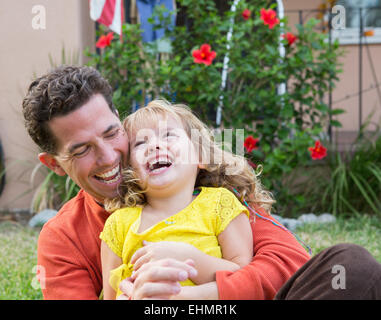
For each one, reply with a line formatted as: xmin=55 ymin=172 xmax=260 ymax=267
xmin=37 ymin=190 xmax=309 ymax=300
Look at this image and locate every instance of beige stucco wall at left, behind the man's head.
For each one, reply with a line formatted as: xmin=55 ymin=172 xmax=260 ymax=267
xmin=0 ymin=0 xmax=95 ymax=208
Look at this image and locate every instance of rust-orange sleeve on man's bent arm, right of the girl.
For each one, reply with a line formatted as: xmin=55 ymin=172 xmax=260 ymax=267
xmin=212 ymin=208 xmax=310 ymax=300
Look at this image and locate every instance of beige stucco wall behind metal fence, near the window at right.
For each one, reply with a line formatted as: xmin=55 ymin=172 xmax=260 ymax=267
xmin=283 ymin=0 xmax=381 ymax=142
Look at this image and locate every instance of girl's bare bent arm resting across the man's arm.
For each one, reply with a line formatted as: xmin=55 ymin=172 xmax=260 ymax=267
xmin=131 ymin=214 xmax=253 ymax=284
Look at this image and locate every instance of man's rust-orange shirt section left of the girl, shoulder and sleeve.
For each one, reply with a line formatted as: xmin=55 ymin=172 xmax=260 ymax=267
xmin=37 ymin=190 xmax=109 ymax=300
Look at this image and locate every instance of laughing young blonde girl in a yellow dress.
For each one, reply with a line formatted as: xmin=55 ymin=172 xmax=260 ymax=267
xmin=100 ymin=100 xmax=273 ymax=299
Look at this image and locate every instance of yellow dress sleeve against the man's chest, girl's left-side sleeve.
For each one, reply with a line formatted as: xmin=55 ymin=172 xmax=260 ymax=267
xmin=99 ymin=210 xmax=124 ymax=257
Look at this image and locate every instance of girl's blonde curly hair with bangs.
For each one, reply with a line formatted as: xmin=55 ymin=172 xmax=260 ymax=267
xmin=105 ymin=100 xmax=275 ymax=213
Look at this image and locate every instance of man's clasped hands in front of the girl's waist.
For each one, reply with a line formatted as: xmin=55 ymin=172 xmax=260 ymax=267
xmin=118 ymin=258 xmax=197 ymax=300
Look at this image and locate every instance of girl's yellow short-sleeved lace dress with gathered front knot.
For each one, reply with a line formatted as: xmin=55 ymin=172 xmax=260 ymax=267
xmin=100 ymin=187 xmax=249 ymax=296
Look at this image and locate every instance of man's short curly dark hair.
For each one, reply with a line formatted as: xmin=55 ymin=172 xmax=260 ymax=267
xmin=22 ymin=66 xmax=117 ymax=154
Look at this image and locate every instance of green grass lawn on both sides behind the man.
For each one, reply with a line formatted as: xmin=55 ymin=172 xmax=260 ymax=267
xmin=0 ymin=216 xmax=381 ymax=300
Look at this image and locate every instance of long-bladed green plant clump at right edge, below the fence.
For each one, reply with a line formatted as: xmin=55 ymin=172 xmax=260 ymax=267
xmin=291 ymin=130 xmax=381 ymax=217
